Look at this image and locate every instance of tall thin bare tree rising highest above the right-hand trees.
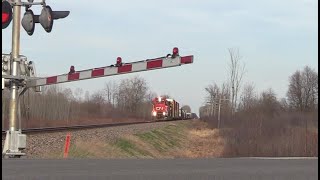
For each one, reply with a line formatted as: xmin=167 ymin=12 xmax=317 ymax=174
xmin=228 ymin=48 xmax=245 ymax=114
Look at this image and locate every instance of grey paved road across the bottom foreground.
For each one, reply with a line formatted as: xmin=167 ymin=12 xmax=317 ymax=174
xmin=2 ymin=158 xmax=318 ymax=180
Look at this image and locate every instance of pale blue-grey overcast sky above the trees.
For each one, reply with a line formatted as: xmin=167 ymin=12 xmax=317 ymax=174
xmin=2 ymin=0 xmax=318 ymax=112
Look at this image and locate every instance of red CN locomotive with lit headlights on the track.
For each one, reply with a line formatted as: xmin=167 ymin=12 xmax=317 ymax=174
xmin=152 ymin=97 xmax=186 ymax=120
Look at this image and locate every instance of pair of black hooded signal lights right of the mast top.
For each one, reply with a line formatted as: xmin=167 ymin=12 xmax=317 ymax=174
xmin=21 ymin=6 xmax=70 ymax=36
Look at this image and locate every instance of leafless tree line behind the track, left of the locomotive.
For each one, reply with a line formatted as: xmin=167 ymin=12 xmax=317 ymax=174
xmin=2 ymin=76 xmax=156 ymax=128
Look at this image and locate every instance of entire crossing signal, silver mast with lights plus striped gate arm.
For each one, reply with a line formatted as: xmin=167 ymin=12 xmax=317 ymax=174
xmin=2 ymin=0 xmax=193 ymax=158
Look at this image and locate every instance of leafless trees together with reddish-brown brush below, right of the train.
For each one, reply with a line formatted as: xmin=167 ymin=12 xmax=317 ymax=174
xmin=199 ymin=47 xmax=318 ymax=156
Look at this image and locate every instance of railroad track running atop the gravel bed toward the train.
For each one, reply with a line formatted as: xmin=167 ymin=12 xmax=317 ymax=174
xmin=2 ymin=119 xmax=190 ymax=135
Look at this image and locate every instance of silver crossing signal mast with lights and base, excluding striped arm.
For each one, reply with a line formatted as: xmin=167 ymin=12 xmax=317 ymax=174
xmin=2 ymin=0 xmax=69 ymax=157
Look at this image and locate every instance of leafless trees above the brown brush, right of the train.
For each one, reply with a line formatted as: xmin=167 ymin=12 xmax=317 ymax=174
xmin=200 ymin=49 xmax=318 ymax=126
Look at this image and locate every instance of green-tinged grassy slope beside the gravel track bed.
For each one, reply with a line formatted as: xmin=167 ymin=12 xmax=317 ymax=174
xmin=49 ymin=122 xmax=188 ymax=158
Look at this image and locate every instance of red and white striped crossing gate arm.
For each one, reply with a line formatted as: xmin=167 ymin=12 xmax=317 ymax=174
xmin=26 ymin=55 xmax=193 ymax=87
